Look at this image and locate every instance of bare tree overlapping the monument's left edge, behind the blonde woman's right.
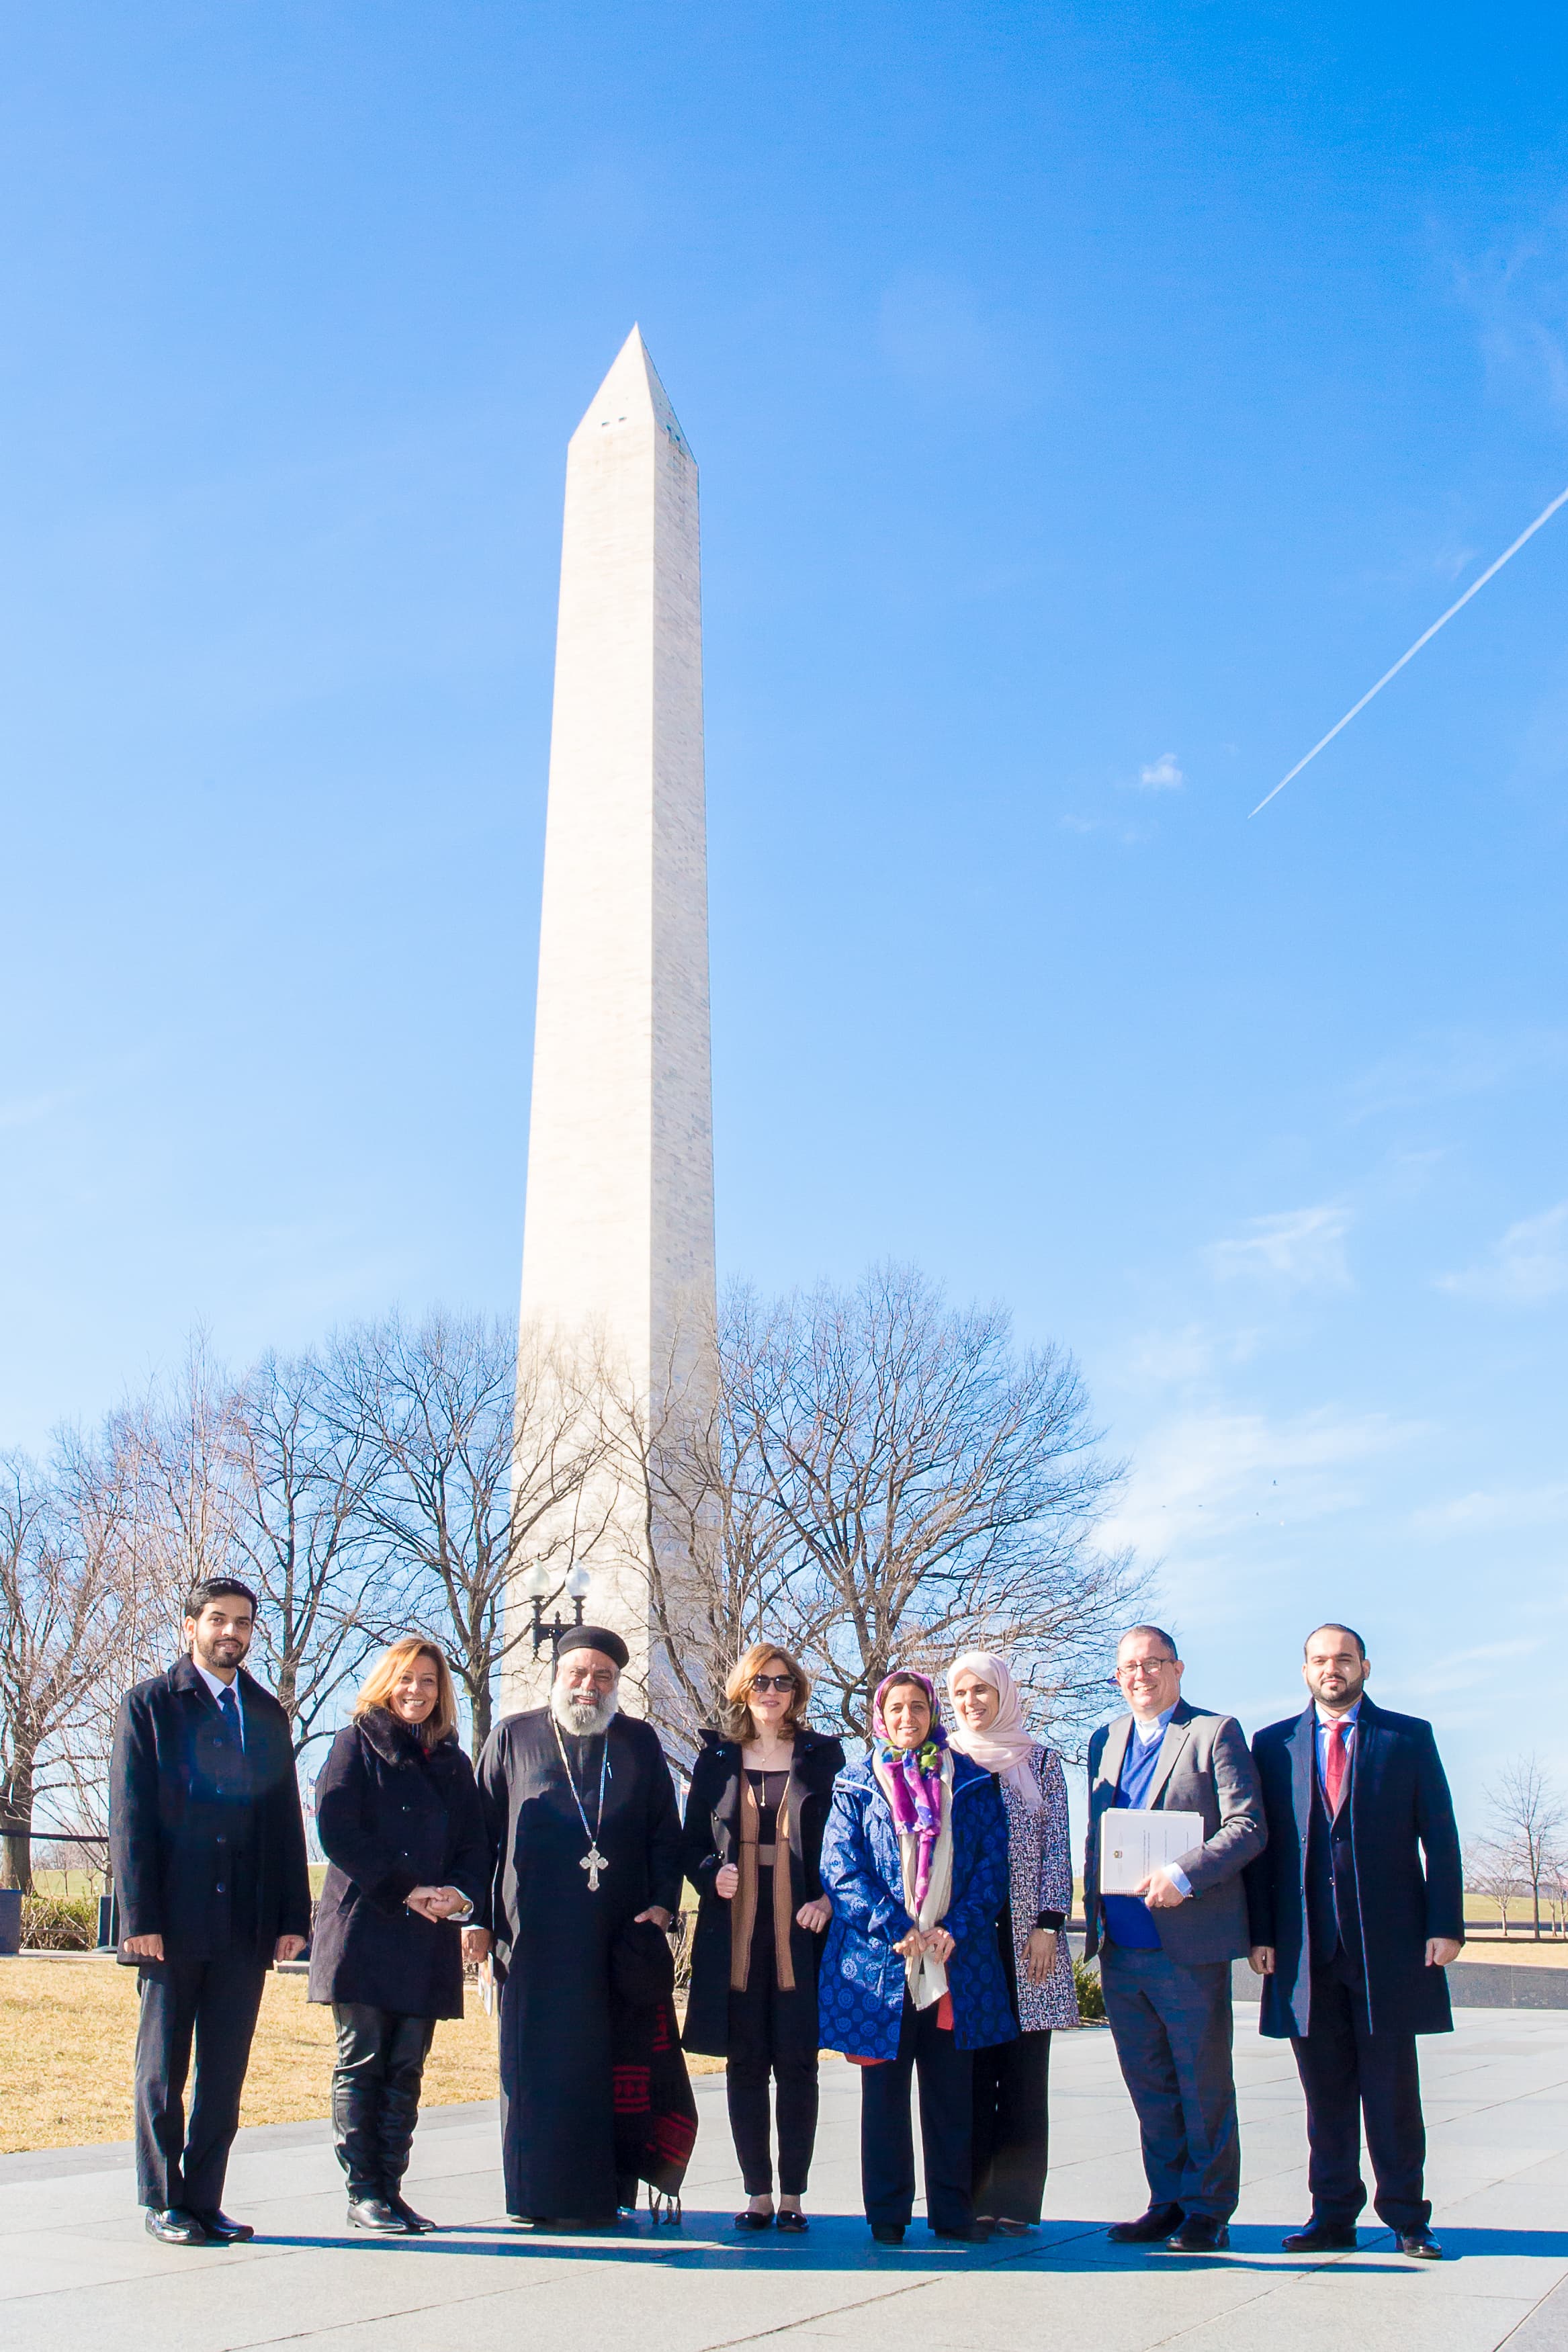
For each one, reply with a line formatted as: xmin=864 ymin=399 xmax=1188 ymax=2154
xmin=329 ymin=1315 xmax=604 ymax=1750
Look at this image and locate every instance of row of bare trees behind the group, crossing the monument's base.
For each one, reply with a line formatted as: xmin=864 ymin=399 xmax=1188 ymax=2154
xmin=0 ymin=1268 xmax=1143 ymax=1886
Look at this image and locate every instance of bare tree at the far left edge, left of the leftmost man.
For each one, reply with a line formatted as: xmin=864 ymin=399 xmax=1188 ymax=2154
xmin=0 ymin=1435 xmax=129 ymax=1888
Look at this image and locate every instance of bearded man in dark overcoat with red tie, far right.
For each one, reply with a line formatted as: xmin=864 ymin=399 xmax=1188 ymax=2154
xmin=1246 ymin=1625 xmax=1465 ymax=2260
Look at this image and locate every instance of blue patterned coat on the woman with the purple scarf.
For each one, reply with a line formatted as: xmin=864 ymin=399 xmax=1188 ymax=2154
xmin=818 ymin=1752 xmax=1018 ymax=2058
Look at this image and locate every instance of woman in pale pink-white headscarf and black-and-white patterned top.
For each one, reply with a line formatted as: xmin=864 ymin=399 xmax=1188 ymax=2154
xmin=947 ymin=1649 xmax=1079 ymax=2236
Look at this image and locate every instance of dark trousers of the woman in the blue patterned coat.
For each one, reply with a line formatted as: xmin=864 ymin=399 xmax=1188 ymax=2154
xmin=861 ymin=1992 xmax=975 ymax=2230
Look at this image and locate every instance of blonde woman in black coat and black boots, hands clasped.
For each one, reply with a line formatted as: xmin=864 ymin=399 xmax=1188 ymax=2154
xmin=310 ymin=1635 xmax=489 ymax=2236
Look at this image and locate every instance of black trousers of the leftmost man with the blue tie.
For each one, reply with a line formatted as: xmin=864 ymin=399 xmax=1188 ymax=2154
xmin=136 ymin=1954 xmax=265 ymax=2213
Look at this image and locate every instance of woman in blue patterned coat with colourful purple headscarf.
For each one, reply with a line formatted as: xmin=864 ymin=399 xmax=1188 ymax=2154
xmin=818 ymin=1670 xmax=1018 ymax=2246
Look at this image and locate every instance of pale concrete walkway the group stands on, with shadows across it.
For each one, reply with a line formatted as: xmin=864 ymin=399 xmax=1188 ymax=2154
xmin=0 ymin=2011 xmax=1568 ymax=2352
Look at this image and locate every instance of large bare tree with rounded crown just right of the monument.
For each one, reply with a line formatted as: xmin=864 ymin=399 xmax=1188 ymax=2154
xmin=629 ymin=1268 xmax=1138 ymax=1736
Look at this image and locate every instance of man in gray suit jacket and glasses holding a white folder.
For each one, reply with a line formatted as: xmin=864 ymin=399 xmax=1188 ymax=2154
xmin=1084 ymin=1625 xmax=1267 ymax=2253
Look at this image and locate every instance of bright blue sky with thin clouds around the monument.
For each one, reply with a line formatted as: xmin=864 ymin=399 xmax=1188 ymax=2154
xmin=0 ymin=0 xmax=1568 ymax=1823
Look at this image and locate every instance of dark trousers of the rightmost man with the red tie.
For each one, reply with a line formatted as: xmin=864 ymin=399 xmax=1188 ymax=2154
xmin=1291 ymin=1950 xmax=1432 ymax=2230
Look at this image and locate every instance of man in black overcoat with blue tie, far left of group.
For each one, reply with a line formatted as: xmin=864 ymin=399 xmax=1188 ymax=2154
xmin=108 ymin=1576 xmax=310 ymax=2246
